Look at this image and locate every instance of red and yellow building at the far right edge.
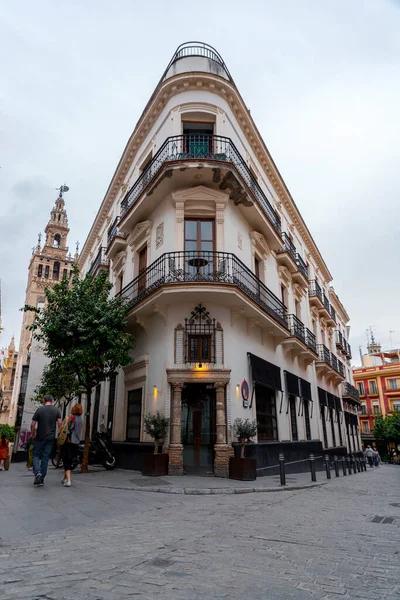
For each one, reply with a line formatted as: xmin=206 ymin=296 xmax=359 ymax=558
xmin=353 ymin=338 xmax=400 ymax=445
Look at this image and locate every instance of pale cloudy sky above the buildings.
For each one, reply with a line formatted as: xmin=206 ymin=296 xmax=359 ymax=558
xmin=0 ymin=0 xmax=400 ymax=364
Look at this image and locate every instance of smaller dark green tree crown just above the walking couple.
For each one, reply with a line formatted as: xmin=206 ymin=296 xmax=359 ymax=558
xmin=33 ymin=358 xmax=86 ymax=406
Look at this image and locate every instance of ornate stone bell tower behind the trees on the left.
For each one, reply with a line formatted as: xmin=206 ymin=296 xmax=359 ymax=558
xmin=10 ymin=188 xmax=75 ymax=452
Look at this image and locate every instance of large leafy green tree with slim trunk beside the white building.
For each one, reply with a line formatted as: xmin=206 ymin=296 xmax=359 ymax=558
xmin=24 ymin=265 xmax=133 ymax=473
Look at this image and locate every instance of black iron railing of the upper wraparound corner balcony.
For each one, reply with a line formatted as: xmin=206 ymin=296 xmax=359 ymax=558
xmin=121 ymin=134 xmax=281 ymax=235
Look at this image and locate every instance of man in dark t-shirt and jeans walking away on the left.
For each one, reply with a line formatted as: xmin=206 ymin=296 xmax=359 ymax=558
xmin=31 ymin=396 xmax=62 ymax=486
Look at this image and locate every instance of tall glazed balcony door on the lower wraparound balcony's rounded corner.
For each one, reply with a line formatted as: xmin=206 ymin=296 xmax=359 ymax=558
xmin=184 ymin=219 xmax=215 ymax=280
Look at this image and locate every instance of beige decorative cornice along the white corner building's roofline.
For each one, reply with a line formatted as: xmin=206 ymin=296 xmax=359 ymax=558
xmin=79 ymin=72 xmax=332 ymax=283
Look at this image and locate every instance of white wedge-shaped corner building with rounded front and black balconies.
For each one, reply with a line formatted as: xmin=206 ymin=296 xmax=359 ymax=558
xmin=80 ymin=43 xmax=360 ymax=476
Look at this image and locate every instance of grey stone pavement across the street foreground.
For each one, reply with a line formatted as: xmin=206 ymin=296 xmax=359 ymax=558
xmin=0 ymin=465 xmax=400 ymax=600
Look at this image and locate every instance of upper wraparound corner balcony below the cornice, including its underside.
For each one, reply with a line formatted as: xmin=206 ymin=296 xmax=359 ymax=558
xmin=120 ymin=134 xmax=282 ymax=250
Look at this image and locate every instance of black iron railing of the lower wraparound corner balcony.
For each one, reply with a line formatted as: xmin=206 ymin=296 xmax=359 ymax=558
xmin=119 ymin=251 xmax=288 ymax=328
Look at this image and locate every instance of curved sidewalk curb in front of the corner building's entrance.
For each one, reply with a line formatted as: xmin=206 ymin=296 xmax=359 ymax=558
xmin=86 ymin=481 xmax=328 ymax=496
